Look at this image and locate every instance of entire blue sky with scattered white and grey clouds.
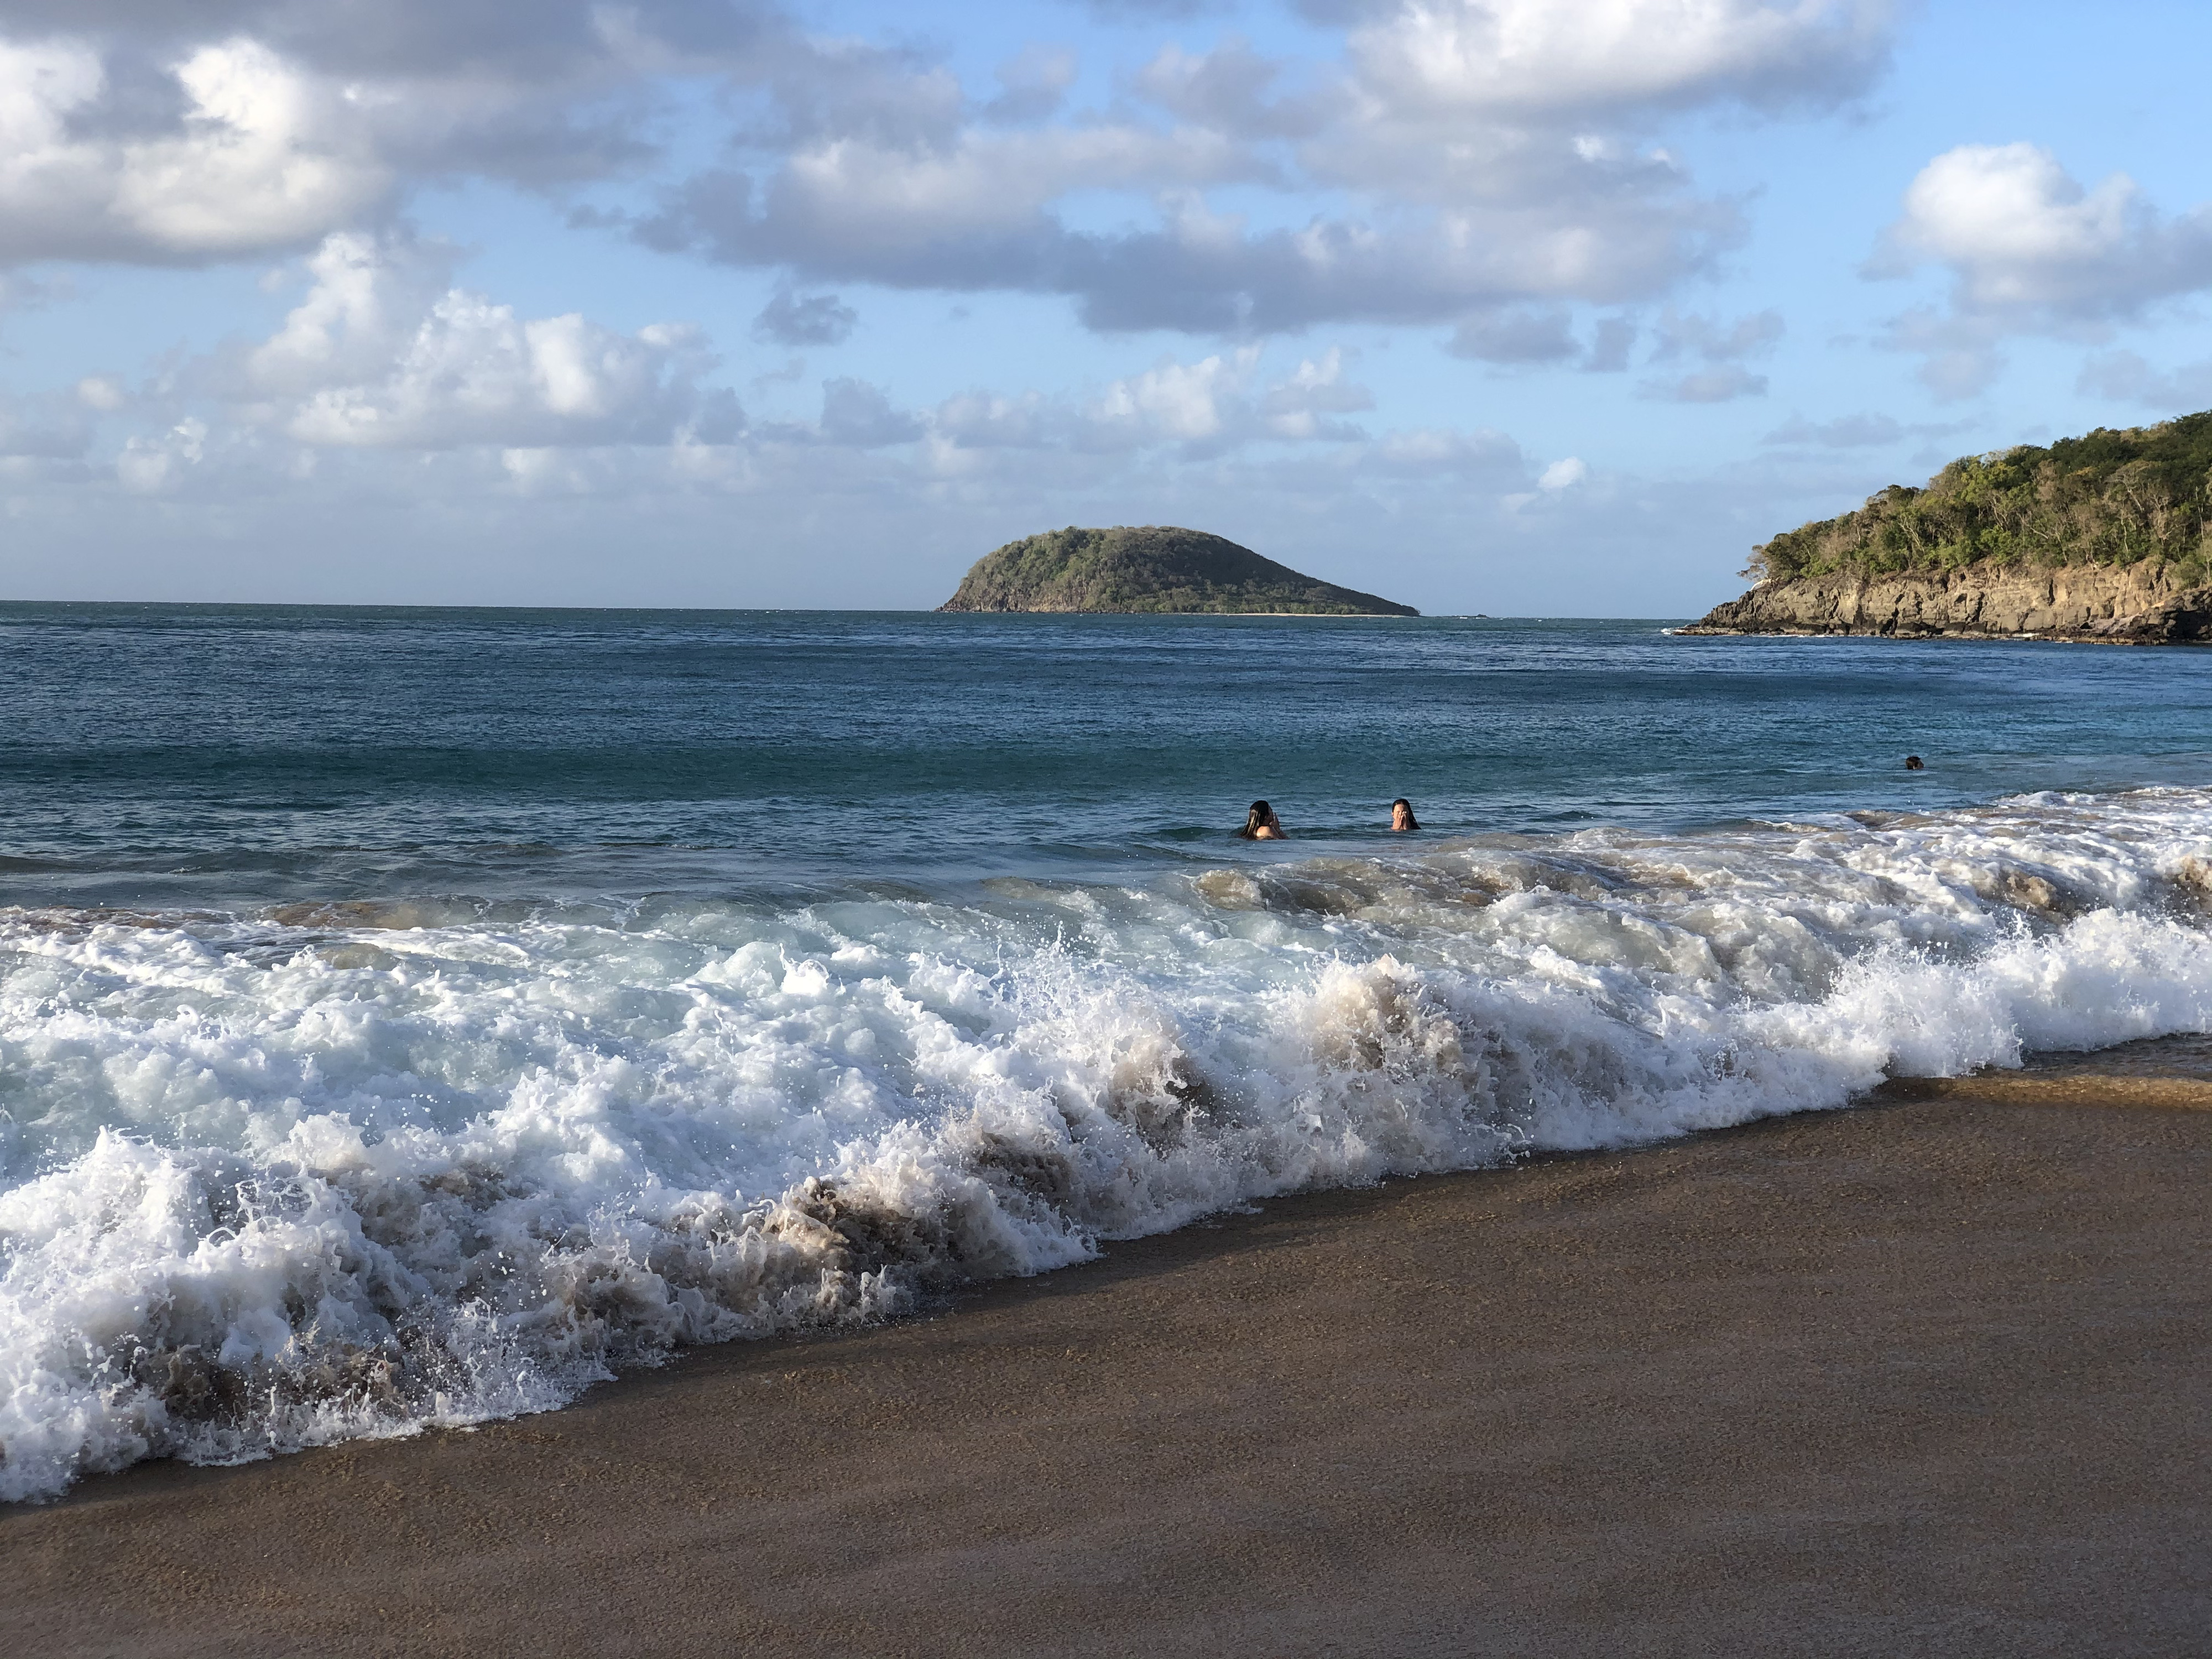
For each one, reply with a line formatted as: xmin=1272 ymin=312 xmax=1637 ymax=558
xmin=0 ymin=0 xmax=2212 ymax=617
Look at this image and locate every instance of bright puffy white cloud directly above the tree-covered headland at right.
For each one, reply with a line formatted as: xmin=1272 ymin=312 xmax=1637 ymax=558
xmin=1867 ymin=144 xmax=2212 ymax=398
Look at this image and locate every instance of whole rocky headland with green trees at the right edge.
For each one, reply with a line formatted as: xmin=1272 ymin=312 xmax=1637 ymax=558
xmin=1681 ymin=414 xmax=2212 ymax=646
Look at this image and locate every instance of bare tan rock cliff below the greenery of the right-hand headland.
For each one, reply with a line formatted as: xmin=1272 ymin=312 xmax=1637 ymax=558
xmin=1681 ymin=560 xmax=2212 ymax=646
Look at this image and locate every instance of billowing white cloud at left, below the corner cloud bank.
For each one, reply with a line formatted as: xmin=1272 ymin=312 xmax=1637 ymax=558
xmin=229 ymin=232 xmax=739 ymax=449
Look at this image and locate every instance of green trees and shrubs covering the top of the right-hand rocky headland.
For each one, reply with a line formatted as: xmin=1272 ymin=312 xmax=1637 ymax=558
xmin=1745 ymin=414 xmax=2212 ymax=586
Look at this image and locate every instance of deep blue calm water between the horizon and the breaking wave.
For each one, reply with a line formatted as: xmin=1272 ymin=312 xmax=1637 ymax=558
xmin=0 ymin=604 xmax=2212 ymax=905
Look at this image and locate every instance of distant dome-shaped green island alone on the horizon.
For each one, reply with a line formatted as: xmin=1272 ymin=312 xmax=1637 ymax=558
xmin=938 ymin=524 xmax=1420 ymax=617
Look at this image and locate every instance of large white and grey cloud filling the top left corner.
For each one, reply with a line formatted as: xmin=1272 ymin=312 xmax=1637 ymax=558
xmin=0 ymin=0 xmax=812 ymax=263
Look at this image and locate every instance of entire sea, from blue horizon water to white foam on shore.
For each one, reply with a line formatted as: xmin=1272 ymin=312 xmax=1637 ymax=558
xmin=0 ymin=606 xmax=2212 ymax=1500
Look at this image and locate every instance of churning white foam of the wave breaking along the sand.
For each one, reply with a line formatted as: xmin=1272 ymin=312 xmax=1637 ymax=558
xmin=0 ymin=790 xmax=2212 ymax=1500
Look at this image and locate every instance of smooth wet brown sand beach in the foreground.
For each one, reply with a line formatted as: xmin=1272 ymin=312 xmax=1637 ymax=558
xmin=0 ymin=1093 xmax=2212 ymax=1659
